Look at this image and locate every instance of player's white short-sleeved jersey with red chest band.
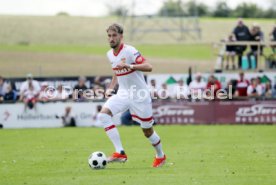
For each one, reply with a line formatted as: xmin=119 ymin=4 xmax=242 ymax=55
xmin=107 ymin=44 xmax=150 ymax=101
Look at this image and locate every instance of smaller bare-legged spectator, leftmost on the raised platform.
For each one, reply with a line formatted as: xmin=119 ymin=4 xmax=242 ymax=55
xmin=225 ymin=34 xmax=236 ymax=70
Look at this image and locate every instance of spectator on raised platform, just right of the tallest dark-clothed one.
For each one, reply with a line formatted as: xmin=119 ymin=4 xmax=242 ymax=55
xmin=247 ymin=23 xmax=264 ymax=69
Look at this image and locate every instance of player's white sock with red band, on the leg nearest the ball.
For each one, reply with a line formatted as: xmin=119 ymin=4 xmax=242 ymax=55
xmin=98 ymin=113 xmax=124 ymax=153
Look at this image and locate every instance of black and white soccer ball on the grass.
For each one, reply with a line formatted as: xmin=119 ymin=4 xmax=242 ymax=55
xmin=88 ymin=151 xmax=107 ymax=169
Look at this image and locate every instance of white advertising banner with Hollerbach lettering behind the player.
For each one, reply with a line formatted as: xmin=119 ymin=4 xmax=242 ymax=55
xmin=0 ymin=102 xmax=121 ymax=128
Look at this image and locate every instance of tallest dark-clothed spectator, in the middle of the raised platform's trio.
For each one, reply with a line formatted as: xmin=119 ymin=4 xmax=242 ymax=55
xmin=233 ymin=18 xmax=250 ymax=69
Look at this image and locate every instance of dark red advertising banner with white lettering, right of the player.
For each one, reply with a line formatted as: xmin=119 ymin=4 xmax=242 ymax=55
xmin=153 ymin=100 xmax=276 ymax=124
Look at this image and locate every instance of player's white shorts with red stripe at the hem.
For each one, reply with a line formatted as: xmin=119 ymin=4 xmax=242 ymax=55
xmin=103 ymin=95 xmax=154 ymax=128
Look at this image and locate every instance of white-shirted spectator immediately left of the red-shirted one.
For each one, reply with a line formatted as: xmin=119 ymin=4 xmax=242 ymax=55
xmin=189 ymin=73 xmax=206 ymax=99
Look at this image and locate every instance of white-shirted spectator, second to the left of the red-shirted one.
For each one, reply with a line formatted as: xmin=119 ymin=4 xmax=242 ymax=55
xmin=171 ymin=79 xmax=190 ymax=99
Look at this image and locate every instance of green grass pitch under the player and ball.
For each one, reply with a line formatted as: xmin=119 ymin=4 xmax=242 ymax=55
xmin=0 ymin=126 xmax=276 ymax=185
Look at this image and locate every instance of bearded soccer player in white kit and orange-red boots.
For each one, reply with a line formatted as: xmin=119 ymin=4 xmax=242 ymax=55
xmin=98 ymin=23 xmax=166 ymax=167
